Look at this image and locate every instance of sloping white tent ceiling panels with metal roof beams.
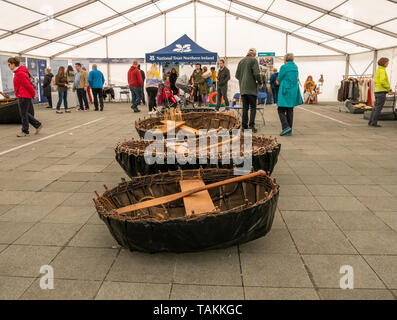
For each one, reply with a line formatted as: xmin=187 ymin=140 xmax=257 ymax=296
xmin=0 ymin=0 xmax=397 ymax=57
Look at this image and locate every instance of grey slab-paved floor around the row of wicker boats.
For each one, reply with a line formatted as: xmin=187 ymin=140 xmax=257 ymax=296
xmin=0 ymin=104 xmax=397 ymax=299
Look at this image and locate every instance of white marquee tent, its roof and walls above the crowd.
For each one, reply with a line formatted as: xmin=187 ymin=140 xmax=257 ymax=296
xmin=0 ymin=0 xmax=397 ymax=100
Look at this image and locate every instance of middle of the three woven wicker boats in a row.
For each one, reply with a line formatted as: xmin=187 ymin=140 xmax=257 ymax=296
xmin=115 ymin=135 xmax=281 ymax=178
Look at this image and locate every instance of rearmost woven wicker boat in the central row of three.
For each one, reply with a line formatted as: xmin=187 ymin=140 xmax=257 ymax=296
xmin=135 ymin=111 xmax=240 ymax=138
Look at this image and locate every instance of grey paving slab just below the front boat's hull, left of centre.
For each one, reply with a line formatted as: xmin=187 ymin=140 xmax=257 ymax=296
xmin=106 ymin=249 xmax=176 ymax=283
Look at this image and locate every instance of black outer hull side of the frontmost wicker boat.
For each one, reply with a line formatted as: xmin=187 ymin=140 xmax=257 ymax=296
xmin=99 ymin=193 xmax=279 ymax=253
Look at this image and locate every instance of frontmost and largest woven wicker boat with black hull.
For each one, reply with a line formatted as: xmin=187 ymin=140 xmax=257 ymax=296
xmin=94 ymin=169 xmax=279 ymax=252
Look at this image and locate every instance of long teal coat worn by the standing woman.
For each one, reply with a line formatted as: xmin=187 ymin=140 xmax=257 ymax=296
xmin=277 ymin=61 xmax=303 ymax=108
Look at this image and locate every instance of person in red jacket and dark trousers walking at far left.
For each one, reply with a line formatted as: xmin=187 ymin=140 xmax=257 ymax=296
xmin=8 ymin=57 xmax=43 ymax=138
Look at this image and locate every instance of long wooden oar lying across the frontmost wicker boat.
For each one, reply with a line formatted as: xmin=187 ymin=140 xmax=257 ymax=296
xmin=116 ymin=170 xmax=266 ymax=214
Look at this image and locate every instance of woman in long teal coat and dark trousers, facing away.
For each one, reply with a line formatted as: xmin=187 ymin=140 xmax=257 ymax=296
xmin=277 ymin=53 xmax=303 ymax=136
